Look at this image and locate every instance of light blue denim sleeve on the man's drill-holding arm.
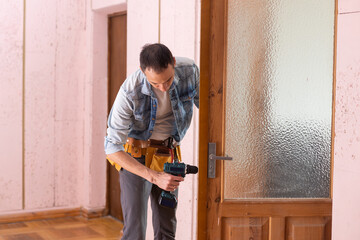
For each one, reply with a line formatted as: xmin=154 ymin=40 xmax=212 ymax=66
xmin=104 ymin=87 xmax=133 ymax=154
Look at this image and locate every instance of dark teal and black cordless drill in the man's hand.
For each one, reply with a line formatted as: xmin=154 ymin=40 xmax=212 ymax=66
xmin=159 ymin=162 xmax=198 ymax=208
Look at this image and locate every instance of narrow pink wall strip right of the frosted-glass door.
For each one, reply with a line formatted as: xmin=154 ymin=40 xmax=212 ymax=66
xmin=332 ymin=11 xmax=360 ymax=240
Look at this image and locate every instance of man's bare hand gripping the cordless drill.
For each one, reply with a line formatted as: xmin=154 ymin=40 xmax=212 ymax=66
xmin=151 ymin=171 xmax=184 ymax=192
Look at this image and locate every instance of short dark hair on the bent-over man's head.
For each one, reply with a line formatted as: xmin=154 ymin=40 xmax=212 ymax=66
xmin=140 ymin=43 xmax=174 ymax=73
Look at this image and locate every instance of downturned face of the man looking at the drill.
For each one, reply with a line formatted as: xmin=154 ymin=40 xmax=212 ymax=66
xmin=144 ymin=64 xmax=175 ymax=92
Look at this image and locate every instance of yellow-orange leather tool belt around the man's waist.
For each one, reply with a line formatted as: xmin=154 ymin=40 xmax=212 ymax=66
xmin=108 ymin=137 xmax=181 ymax=172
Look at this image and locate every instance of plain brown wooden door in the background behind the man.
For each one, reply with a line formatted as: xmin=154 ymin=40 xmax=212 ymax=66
xmin=107 ymin=13 xmax=126 ymax=221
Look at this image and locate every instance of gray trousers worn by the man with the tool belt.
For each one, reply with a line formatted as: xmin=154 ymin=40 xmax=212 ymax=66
xmin=120 ymin=158 xmax=178 ymax=240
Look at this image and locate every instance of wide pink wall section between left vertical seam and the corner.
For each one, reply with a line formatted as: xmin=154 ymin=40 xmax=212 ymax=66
xmin=24 ymin=1 xmax=86 ymax=209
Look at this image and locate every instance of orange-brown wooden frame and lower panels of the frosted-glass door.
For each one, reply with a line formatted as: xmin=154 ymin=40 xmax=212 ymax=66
xmin=198 ymin=0 xmax=333 ymax=240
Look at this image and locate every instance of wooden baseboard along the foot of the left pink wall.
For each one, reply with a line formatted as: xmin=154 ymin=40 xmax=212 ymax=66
xmin=0 ymin=208 xmax=108 ymax=223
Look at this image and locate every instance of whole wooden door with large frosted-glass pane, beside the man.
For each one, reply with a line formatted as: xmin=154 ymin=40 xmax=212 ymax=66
xmin=198 ymin=0 xmax=335 ymax=240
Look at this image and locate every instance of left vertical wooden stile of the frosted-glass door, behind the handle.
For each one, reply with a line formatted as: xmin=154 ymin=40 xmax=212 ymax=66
xmin=197 ymin=0 xmax=225 ymax=239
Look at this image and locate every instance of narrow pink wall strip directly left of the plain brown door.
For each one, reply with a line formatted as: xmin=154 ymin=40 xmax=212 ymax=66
xmin=79 ymin=13 xmax=108 ymax=208
